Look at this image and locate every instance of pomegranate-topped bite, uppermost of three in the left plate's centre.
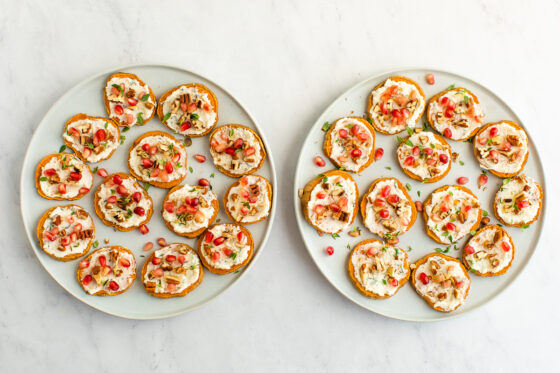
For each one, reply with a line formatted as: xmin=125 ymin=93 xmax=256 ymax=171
xmin=128 ymin=131 xmax=187 ymax=188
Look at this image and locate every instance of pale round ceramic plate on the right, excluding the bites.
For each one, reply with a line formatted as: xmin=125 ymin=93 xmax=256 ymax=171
xmin=293 ymin=69 xmax=546 ymax=321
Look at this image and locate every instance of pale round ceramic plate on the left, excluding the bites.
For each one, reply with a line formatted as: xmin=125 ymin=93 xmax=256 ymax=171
xmin=21 ymin=65 xmax=276 ymax=319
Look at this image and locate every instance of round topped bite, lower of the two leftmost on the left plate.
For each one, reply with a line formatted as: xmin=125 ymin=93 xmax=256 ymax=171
xmin=37 ymin=205 xmax=95 ymax=262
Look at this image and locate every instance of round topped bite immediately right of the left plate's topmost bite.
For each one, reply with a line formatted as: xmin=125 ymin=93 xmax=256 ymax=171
xmin=157 ymin=84 xmax=218 ymax=137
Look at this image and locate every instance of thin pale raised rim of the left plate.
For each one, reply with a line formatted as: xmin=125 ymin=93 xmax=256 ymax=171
xmin=19 ymin=62 xmax=278 ymax=320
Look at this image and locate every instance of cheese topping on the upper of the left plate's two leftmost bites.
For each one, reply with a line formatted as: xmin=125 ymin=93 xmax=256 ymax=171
xmin=39 ymin=153 xmax=93 ymax=198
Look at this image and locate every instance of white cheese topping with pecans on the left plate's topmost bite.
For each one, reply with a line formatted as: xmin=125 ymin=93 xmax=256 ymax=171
xmin=105 ymin=77 xmax=156 ymax=127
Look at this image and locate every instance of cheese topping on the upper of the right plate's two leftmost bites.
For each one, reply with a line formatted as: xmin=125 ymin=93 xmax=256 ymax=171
xmin=330 ymin=118 xmax=373 ymax=171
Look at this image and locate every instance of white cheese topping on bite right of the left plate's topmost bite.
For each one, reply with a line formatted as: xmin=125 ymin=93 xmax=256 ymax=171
xmin=163 ymin=85 xmax=217 ymax=136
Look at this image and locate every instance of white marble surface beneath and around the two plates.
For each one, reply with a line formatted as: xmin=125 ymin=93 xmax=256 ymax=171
xmin=0 ymin=0 xmax=560 ymax=372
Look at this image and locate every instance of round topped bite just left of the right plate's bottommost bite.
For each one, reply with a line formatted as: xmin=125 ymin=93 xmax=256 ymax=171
xmin=348 ymin=238 xmax=410 ymax=299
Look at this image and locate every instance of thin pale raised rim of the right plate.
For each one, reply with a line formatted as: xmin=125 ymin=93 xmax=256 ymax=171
xmin=293 ymin=66 xmax=548 ymax=323
